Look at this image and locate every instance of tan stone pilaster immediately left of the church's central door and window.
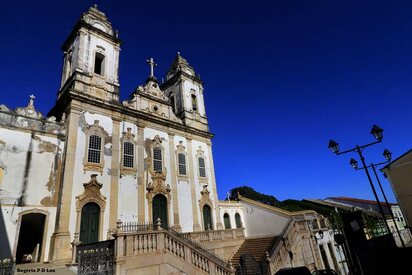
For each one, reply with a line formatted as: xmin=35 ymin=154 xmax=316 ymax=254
xmin=137 ymin=123 xmax=146 ymax=222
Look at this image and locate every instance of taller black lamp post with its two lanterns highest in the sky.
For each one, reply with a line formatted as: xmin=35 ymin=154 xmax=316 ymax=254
xmin=328 ymin=124 xmax=391 ymax=237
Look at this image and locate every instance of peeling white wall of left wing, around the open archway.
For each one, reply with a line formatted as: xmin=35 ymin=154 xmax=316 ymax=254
xmin=0 ymin=127 xmax=64 ymax=260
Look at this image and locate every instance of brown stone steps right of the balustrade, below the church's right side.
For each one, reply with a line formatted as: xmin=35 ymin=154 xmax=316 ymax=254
xmin=232 ymin=236 xmax=278 ymax=268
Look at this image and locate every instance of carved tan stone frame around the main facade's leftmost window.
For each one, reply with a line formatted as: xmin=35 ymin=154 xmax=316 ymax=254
xmin=82 ymin=120 xmax=109 ymax=173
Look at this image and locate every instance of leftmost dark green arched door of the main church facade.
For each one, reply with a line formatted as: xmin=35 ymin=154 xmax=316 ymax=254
xmin=80 ymin=202 xmax=100 ymax=244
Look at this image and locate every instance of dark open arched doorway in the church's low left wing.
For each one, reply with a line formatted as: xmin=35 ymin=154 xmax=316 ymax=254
xmin=16 ymin=213 xmax=46 ymax=264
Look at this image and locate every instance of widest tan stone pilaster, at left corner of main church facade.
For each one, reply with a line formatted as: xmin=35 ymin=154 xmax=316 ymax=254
xmin=50 ymin=107 xmax=80 ymax=262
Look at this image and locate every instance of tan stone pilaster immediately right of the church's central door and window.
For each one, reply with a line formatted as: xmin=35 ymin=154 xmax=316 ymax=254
xmin=168 ymin=133 xmax=182 ymax=231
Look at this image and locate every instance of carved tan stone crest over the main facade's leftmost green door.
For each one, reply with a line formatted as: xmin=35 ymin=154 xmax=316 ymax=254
xmin=76 ymin=174 xmax=106 ymax=212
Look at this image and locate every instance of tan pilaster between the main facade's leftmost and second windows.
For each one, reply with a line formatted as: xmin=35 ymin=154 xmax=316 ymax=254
xmin=109 ymin=118 xmax=120 ymax=229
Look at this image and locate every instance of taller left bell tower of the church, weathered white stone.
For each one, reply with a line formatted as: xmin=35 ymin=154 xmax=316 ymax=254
xmin=58 ymin=5 xmax=121 ymax=104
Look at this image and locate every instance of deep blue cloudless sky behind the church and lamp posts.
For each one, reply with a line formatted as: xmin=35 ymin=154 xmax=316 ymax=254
xmin=0 ymin=0 xmax=412 ymax=201
